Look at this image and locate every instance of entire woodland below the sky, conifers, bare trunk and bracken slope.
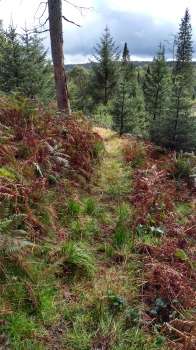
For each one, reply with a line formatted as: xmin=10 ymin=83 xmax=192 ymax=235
xmin=0 ymin=0 xmax=196 ymax=350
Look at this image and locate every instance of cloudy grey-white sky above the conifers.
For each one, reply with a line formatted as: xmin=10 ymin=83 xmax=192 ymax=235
xmin=0 ymin=0 xmax=196 ymax=63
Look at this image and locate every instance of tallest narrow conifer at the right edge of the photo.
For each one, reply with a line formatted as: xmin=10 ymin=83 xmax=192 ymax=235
xmin=162 ymin=10 xmax=196 ymax=151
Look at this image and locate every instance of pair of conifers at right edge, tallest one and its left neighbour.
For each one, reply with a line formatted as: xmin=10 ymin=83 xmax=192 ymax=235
xmin=143 ymin=10 xmax=196 ymax=151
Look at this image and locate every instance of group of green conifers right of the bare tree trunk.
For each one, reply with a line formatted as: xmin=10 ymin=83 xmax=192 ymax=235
xmin=69 ymin=9 xmax=196 ymax=150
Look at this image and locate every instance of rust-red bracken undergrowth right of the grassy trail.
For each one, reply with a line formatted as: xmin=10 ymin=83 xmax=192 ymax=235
xmin=124 ymin=135 xmax=196 ymax=349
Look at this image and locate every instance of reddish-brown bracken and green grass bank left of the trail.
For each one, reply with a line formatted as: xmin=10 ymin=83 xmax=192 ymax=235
xmin=0 ymin=96 xmax=103 ymax=349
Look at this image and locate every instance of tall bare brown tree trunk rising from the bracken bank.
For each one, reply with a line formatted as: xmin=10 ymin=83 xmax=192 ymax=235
xmin=48 ymin=0 xmax=71 ymax=115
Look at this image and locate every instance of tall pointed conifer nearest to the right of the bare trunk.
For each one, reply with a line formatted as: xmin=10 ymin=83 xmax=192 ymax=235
xmin=92 ymin=27 xmax=119 ymax=105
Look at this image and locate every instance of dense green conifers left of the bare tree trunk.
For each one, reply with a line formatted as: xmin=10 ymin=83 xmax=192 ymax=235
xmin=0 ymin=26 xmax=54 ymax=102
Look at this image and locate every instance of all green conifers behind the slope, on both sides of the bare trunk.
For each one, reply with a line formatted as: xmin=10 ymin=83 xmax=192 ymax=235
xmin=0 ymin=9 xmax=196 ymax=151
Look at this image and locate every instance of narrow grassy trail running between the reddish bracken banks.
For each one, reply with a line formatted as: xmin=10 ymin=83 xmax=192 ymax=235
xmin=59 ymin=128 xmax=164 ymax=350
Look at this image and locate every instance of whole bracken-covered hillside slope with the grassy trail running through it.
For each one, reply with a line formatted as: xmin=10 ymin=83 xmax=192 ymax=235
xmin=0 ymin=110 xmax=196 ymax=350
